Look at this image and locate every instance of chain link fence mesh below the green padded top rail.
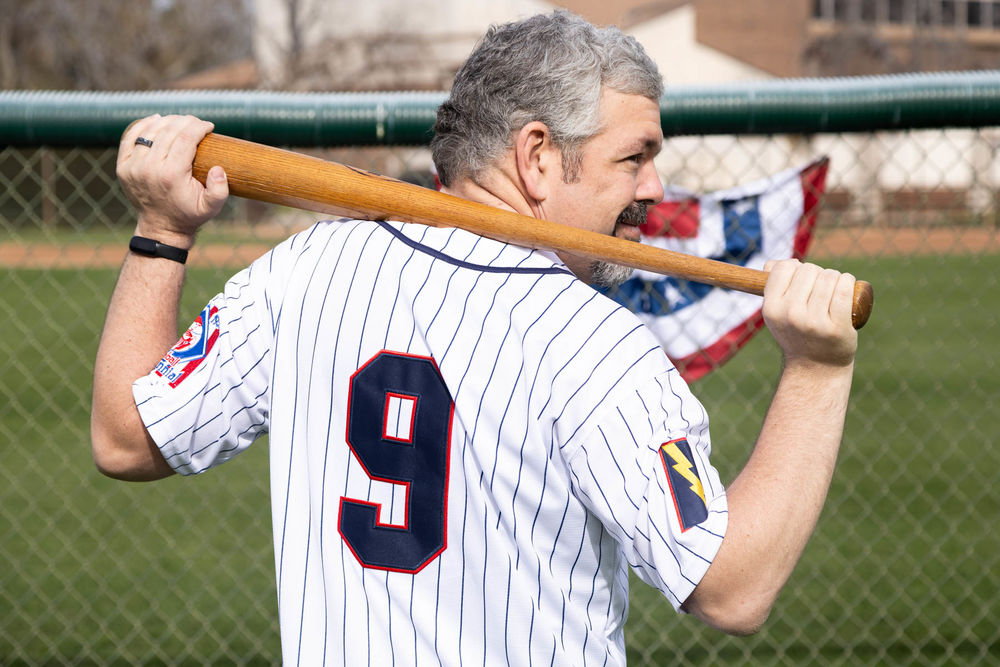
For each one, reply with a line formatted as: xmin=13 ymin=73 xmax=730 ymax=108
xmin=0 ymin=91 xmax=1000 ymax=665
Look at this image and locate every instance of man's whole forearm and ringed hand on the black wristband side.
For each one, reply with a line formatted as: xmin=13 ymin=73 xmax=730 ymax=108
xmin=90 ymin=115 xmax=229 ymax=480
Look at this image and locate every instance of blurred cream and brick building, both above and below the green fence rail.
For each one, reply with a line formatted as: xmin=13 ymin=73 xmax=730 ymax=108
xmin=246 ymin=0 xmax=1000 ymax=222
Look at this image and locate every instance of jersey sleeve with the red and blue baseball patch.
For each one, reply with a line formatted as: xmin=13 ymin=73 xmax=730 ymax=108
xmin=132 ymin=255 xmax=275 ymax=475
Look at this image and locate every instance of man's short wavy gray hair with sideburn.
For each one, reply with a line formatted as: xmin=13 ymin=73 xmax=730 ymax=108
xmin=431 ymin=10 xmax=663 ymax=186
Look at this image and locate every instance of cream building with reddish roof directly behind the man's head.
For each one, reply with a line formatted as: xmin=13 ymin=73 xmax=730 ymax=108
xmin=246 ymin=0 xmax=769 ymax=90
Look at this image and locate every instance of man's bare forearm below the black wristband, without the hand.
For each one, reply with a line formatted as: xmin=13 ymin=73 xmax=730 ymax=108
xmin=91 ymin=223 xmax=191 ymax=480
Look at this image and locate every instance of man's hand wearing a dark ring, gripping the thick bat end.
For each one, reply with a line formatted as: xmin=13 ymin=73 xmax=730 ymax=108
xmin=117 ymin=115 xmax=229 ymax=249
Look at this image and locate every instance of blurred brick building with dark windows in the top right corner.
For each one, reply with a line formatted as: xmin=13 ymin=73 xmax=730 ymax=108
xmin=695 ymin=0 xmax=1000 ymax=77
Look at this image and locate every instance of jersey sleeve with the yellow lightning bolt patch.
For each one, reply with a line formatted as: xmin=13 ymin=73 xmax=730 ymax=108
xmin=569 ymin=367 xmax=728 ymax=609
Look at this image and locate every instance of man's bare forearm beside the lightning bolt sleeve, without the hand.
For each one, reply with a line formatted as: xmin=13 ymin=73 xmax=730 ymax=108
xmin=688 ymin=362 xmax=853 ymax=633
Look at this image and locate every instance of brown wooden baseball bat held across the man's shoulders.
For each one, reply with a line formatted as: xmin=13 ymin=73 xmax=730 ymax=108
xmin=194 ymin=133 xmax=874 ymax=329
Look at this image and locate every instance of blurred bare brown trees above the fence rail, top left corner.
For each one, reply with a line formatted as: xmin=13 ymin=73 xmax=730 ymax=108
xmin=0 ymin=0 xmax=252 ymax=90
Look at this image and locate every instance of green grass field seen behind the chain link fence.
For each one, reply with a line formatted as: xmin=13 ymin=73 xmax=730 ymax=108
xmin=0 ymin=256 xmax=1000 ymax=665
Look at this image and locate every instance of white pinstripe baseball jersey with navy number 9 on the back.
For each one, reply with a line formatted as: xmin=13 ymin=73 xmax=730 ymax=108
xmin=134 ymin=221 xmax=726 ymax=665
